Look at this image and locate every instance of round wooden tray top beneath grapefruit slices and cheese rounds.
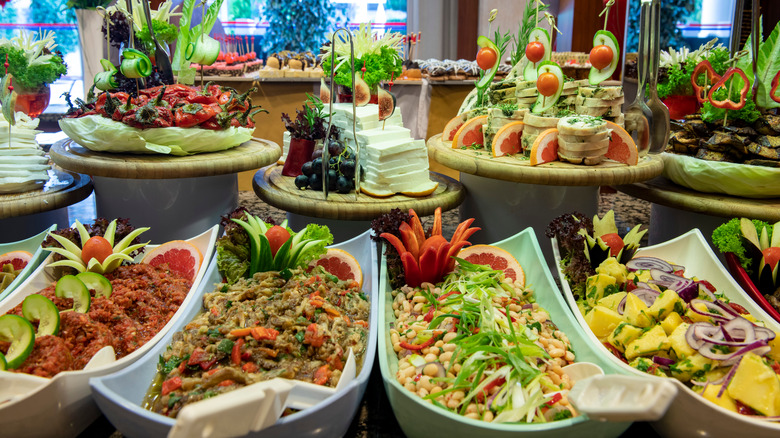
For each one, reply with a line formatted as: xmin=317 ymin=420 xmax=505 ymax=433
xmin=428 ymin=134 xmax=664 ymax=186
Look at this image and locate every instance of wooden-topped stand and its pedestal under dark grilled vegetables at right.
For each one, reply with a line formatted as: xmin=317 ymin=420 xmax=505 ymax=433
xmin=615 ymin=177 xmax=780 ymax=254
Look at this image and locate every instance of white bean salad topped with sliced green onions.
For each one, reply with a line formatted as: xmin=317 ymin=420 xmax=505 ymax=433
xmin=390 ymin=261 xmax=577 ymax=423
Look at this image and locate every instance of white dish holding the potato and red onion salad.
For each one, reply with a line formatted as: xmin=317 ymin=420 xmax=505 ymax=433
xmin=552 ymin=229 xmax=780 ymax=438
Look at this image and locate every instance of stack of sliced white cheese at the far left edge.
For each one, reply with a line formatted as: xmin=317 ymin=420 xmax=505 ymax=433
xmin=0 ymin=112 xmax=51 ymax=193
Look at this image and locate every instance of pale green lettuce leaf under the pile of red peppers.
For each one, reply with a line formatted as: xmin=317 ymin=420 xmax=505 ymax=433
xmin=59 ymin=115 xmax=253 ymax=155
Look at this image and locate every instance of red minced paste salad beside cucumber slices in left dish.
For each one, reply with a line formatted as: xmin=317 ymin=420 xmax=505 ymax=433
xmin=0 ymin=264 xmax=192 ymax=377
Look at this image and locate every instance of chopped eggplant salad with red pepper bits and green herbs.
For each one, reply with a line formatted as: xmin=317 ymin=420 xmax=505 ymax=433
xmin=144 ymin=266 xmax=370 ymax=417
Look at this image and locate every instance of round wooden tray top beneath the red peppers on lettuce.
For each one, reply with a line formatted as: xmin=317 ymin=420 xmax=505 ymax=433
xmin=49 ymin=138 xmax=282 ymax=179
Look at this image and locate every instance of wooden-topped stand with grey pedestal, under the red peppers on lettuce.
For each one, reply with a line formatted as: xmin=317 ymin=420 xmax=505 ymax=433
xmin=50 ymin=138 xmax=281 ymax=242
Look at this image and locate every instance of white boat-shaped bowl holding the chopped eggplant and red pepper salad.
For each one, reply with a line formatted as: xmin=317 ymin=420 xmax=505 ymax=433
xmin=90 ymin=231 xmax=379 ymax=438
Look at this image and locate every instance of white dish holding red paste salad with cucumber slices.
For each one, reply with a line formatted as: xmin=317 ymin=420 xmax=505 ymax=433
xmin=0 ymin=225 xmax=218 ymax=437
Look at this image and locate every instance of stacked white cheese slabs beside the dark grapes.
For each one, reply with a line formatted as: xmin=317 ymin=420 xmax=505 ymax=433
xmin=357 ymin=126 xmax=438 ymax=197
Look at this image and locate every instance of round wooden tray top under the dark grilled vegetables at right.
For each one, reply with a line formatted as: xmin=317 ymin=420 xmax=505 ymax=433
xmin=615 ymin=177 xmax=780 ymax=223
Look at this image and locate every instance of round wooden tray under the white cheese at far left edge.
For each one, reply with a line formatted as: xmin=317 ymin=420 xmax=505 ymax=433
xmin=0 ymin=169 xmax=92 ymax=219
